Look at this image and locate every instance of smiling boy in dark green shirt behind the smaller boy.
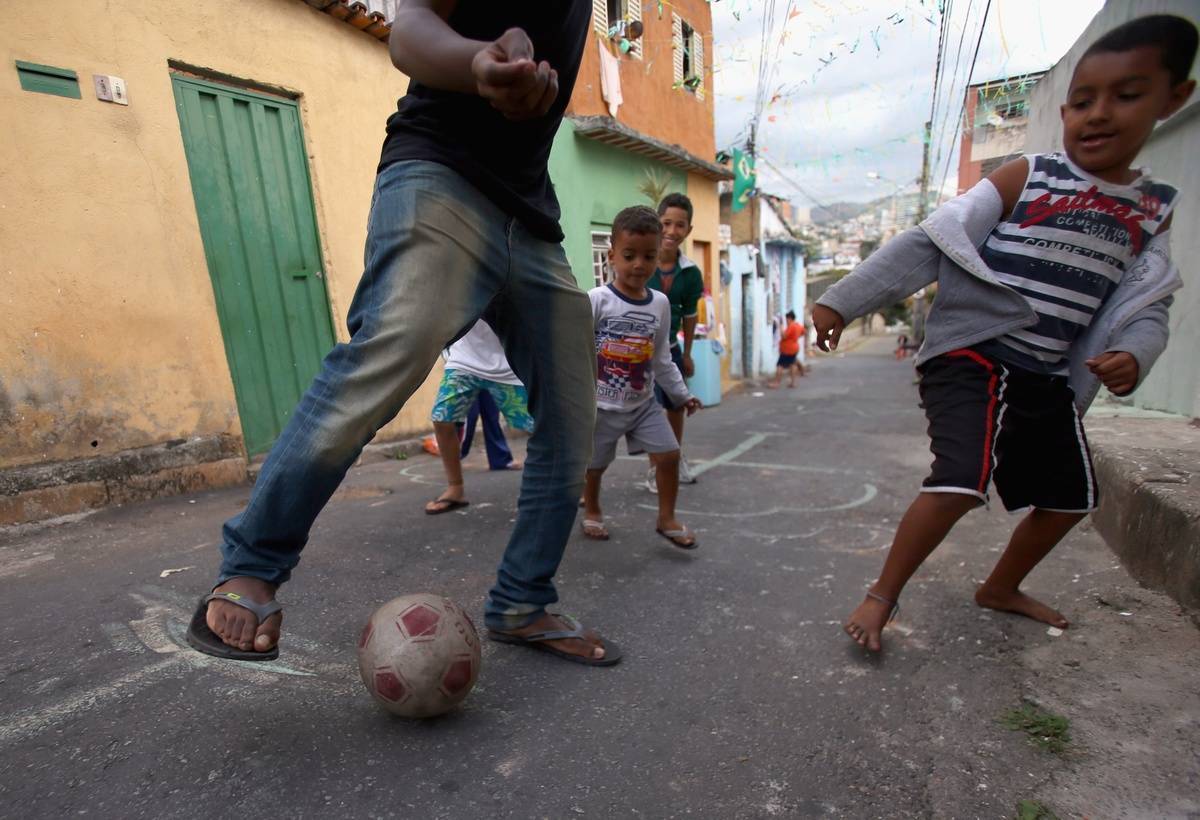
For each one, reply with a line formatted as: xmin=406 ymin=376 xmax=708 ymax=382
xmin=647 ymin=193 xmax=704 ymax=492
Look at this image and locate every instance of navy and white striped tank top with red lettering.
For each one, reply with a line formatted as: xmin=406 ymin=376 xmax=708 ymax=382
xmin=978 ymin=154 xmax=1176 ymax=375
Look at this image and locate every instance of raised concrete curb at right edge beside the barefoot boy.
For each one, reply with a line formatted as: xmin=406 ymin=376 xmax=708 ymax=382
xmin=1088 ymin=417 xmax=1200 ymax=609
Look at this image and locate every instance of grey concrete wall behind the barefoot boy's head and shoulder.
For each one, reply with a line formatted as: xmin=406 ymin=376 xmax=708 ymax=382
xmin=1025 ymin=0 xmax=1200 ymax=417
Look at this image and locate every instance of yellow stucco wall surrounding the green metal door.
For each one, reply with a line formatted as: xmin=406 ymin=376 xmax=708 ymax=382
xmin=0 ymin=0 xmax=433 ymax=468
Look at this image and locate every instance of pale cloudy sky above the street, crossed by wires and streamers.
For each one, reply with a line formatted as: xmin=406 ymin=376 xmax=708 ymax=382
xmin=712 ymin=0 xmax=1104 ymax=205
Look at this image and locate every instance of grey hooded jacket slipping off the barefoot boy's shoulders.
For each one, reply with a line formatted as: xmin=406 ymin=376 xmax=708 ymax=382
xmin=817 ymin=179 xmax=1183 ymax=413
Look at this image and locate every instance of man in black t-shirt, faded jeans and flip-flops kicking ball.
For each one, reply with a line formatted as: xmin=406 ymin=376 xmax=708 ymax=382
xmin=187 ymin=0 xmax=620 ymax=665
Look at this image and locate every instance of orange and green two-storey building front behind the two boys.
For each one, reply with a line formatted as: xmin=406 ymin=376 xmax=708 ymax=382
xmin=550 ymin=0 xmax=732 ymax=393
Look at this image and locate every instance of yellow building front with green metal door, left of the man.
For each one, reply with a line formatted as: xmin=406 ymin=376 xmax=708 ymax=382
xmin=0 ymin=0 xmax=422 ymax=523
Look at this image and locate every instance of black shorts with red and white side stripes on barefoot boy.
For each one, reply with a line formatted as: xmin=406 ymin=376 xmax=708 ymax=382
xmin=920 ymin=349 xmax=1099 ymax=513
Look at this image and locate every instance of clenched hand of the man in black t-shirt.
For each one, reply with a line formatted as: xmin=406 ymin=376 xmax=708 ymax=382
xmin=470 ymin=29 xmax=558 ymax=120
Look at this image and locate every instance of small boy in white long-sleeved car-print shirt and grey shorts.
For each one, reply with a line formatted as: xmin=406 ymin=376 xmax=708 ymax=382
xmin=582 ymin=207 xmax=701 ymax=550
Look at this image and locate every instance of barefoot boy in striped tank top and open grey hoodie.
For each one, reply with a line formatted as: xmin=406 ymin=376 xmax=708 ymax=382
xmin=812 ymin=16 xmax=1196 ymax=651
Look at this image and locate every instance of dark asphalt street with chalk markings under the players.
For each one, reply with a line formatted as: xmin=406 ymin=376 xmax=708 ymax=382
xmin=0 ymin=343 xmax=1195 ymax=819
